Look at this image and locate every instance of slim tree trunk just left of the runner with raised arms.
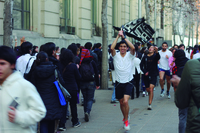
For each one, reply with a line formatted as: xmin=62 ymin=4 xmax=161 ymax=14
xmin=101 ymin=0 xmax=108 ymax=89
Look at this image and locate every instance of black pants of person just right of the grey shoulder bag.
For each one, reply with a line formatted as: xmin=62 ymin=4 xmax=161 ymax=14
xmin=59 ymin=90 xmax=78 ymax=127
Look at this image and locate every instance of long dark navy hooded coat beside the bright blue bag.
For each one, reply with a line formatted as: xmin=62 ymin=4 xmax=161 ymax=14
xmin=32 ymin=61 xmax=64 ymax=120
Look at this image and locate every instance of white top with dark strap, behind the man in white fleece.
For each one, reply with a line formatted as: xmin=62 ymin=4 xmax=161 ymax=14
xmin=16 ymin=54 xmax=36 ymax=75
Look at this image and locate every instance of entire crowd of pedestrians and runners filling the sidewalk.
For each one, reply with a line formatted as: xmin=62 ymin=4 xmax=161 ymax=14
xmin=0 ymin=31 xmax=200 ymax=133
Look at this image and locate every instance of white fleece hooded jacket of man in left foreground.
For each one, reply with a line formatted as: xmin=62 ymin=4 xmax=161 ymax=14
xmin=0 ymin=71 xmax=46 ymax=133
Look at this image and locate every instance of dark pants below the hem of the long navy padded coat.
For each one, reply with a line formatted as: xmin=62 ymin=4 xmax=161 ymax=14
xmin=40 ymin=120 xmax=55 ymax=133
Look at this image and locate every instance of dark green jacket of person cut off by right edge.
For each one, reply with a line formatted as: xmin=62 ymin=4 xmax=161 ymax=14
xmin=175 ymin=60 xmax=200 ymax=133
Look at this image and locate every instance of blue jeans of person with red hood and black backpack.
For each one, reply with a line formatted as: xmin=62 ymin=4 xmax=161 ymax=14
xmin=80 ymin=82 xmax=95 ymax=114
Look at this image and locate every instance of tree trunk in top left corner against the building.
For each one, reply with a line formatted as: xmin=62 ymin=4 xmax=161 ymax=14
xmin=3 ymin=0 xmax=13 ymax=47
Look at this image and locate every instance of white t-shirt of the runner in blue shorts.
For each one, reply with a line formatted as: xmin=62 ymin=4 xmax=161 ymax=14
xmin=158 ymin=49 xmax=172 ymax=70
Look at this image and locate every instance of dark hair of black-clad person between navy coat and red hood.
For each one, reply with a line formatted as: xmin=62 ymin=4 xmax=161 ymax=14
xmin=60 ymin=49 xmax=74 ymax=66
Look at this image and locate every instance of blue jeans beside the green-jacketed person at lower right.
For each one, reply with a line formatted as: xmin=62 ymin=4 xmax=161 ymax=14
xmin=178 ymin=108 xmax=188 ymax=133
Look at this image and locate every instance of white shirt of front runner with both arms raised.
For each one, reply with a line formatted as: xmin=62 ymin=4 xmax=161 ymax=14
xmin=113 ymin=52 xmax=135 ymax=83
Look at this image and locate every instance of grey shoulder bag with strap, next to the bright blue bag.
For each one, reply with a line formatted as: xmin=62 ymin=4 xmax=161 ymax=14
xmin=55 ymin=69 xmax=71 ymax=101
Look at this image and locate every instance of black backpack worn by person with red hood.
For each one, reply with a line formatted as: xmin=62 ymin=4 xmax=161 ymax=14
xmin=79 ymin=61 xmax=95 ymax=81
